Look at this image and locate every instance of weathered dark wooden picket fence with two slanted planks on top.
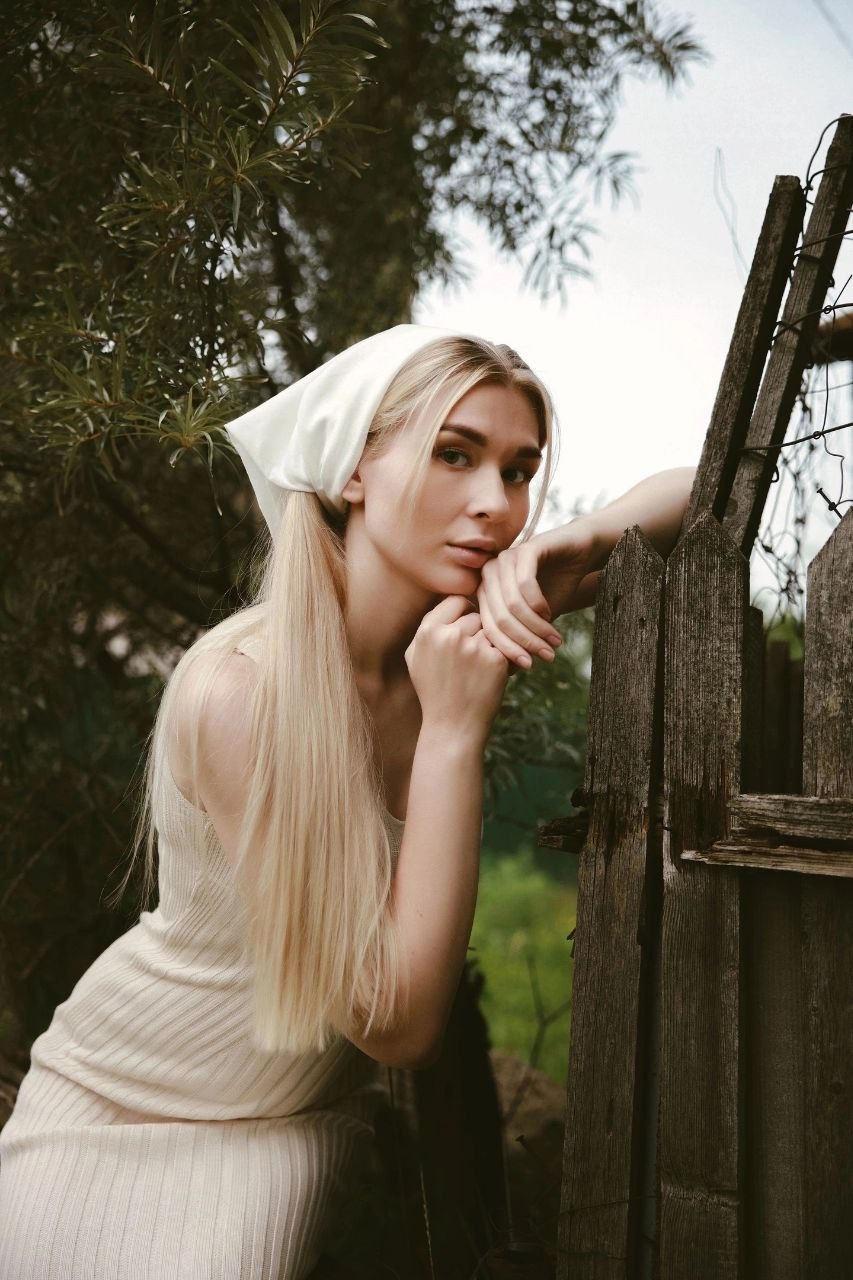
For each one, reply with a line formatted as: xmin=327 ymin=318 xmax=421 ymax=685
xmin=540 ymin=115 xmax=853 ymax=1280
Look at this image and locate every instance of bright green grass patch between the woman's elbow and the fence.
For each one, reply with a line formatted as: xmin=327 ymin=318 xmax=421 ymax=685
xmin=469 ymin=845 xmax=578 ymax=1084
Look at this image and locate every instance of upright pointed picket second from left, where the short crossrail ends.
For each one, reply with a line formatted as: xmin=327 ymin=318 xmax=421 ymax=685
xmin=660 ymin=515 xmax=748 ymax=1280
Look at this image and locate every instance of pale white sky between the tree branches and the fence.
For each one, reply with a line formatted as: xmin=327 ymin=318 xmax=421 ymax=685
xmin=412 ymin=0 xmax=853 ymax=609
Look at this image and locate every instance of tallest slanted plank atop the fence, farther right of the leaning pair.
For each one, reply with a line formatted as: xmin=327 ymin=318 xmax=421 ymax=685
xmin=722 ymin=115 xmax=853 ymax=557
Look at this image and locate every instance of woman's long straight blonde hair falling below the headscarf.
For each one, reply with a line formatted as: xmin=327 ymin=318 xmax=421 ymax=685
xmin=106 ymin=337 xmax=556 ymax=1052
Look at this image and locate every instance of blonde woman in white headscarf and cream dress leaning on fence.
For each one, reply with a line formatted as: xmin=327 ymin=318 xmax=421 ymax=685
xmin=0 ymin=325 xmax=692 ymax=1280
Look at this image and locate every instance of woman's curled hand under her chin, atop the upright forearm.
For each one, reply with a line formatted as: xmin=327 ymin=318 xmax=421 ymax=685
xmin=405 ymin=595 xmax=512 ymax=745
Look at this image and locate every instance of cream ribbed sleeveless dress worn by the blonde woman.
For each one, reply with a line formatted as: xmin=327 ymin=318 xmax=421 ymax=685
xmin=0 ymin=706 xmax=403 ymax=1280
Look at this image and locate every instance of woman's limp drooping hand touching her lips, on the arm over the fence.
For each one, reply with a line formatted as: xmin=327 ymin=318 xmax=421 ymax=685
xmin=476 ymin=517 xmax=601 ymax=667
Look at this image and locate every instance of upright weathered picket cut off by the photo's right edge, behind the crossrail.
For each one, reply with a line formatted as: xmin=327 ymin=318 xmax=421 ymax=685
xmin=802 ymin=508 xmax=853 ymax=1280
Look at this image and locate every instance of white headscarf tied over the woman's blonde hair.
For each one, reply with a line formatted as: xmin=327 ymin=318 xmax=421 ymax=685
xmin=225 ymin=324 xmax=473 ymax=536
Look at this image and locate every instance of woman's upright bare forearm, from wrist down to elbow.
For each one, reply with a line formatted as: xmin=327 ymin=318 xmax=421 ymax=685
xmin=391 ymin=726 xmax=484 ymax=1053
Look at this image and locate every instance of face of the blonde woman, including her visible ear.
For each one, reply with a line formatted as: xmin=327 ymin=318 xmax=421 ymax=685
xmin=343 ymin=384 xmax=542 ymax=595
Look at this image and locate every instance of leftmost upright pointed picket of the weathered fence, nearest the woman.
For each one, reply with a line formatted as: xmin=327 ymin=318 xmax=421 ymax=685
xmin=557 ymin=526 xmax=663 ymax=1280
